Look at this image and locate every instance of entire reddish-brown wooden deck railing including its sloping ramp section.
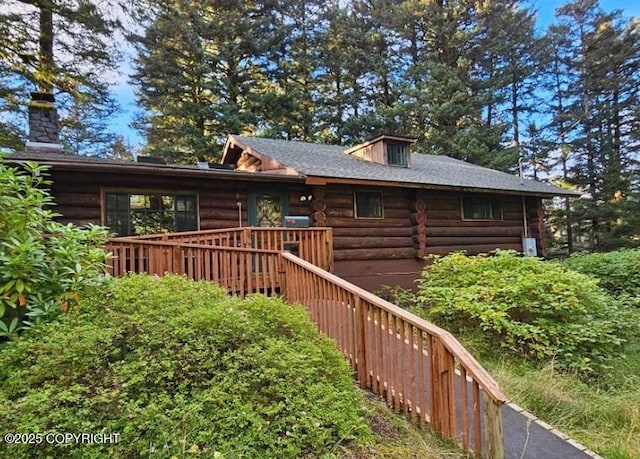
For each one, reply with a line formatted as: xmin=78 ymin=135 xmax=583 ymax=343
xmin=107 ymin=228 xmax=506 ymax=458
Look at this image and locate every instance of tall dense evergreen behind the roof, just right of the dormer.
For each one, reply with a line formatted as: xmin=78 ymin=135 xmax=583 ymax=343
xmin=378 ymin=0 xmax=515 ymax=169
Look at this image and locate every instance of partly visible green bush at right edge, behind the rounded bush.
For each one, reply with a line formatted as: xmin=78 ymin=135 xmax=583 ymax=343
xmin=566 ymin=249 xmax=640 ymax=304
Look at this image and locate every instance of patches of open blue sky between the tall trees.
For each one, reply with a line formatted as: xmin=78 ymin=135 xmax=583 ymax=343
xmin=111 ymin=0 xmax=640 ymax=150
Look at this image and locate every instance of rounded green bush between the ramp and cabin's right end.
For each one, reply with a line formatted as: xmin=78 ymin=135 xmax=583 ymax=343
xmin=418 ymin=251 xmax=629 ymax=372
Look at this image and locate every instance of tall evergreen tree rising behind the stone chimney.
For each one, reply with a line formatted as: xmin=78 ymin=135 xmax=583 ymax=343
xmin=0 ymin=0 xmax=120 ymax=151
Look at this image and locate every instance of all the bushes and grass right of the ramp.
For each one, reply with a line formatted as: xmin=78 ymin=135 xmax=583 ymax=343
xmin=382 ymin=250 xmax=640 ymax=459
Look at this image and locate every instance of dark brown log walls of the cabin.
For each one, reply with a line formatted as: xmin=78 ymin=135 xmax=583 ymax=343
xmin=43 ymin=169 xmax=546 ymax=289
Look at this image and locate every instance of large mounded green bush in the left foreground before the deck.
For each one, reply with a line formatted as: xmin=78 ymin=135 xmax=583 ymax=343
xmin=0 ymin=276 xmax=369 ymax=458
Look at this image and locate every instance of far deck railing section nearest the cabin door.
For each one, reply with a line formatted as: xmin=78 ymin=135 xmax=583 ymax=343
xmin=124 ymin=226 xmax=333 ymax=271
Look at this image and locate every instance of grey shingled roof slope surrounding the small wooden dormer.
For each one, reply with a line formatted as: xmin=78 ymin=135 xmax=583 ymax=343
xmin=231 ymin=136 xmax=576 ymax=195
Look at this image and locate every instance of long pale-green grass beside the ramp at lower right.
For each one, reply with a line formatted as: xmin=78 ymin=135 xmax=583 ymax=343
xmin=461 ymin=330 xmax=640 ymax=459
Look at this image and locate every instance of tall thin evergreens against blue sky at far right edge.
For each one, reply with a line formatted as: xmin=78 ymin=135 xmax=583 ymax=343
xmin=552 ymin=0 xmax=640 ymax=250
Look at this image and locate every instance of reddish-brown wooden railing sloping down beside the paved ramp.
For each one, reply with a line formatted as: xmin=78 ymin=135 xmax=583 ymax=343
xmin=281 ymin=253 xmax=507 ymax=458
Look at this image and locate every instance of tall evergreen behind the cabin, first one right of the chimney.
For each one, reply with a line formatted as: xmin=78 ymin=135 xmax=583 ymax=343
xmin=132 ymin=0 xmax=268 ymax=163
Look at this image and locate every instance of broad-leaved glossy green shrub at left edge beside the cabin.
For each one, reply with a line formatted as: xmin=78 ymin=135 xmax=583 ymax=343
xmin=0 ymin=158 xmax=108 ymax=336
